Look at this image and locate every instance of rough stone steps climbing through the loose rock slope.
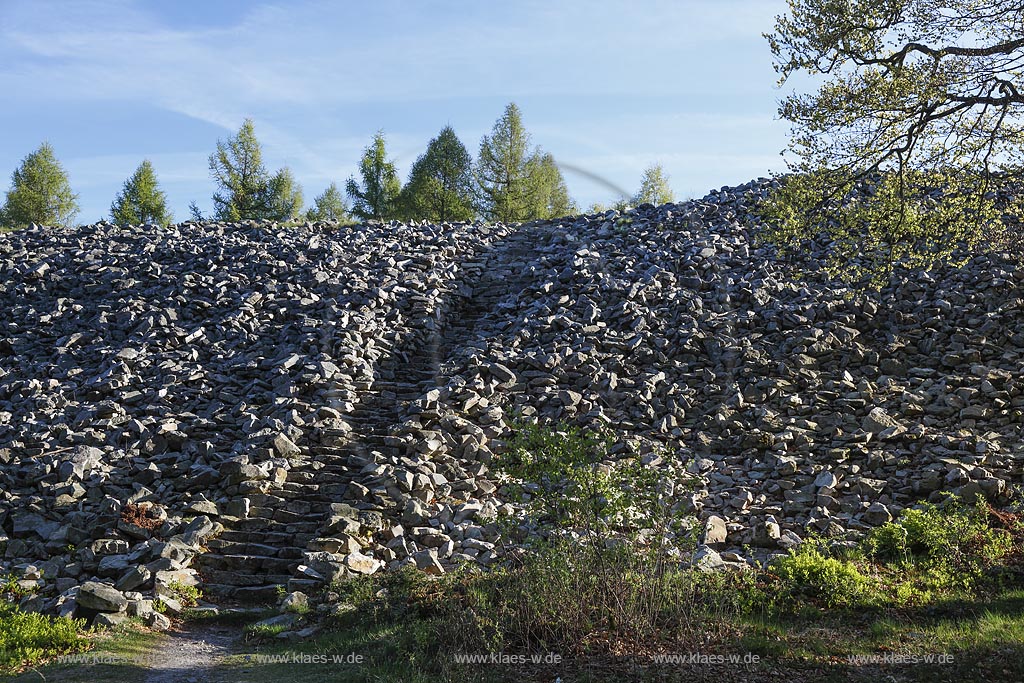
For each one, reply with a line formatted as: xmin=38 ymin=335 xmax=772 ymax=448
xmin=195 ymin=223 xmax=548 ymax=602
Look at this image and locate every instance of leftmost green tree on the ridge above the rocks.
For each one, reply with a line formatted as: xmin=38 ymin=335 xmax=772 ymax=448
xmin=0 ymin=142 xmax=79 ymax=227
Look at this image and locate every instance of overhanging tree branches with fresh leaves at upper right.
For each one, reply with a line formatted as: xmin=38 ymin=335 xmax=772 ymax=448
xmin=762 ymin=0 xmax=1024 ymax=284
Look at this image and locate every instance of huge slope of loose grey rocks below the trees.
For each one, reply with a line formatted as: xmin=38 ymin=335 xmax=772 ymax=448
xmin=0 ymin=181 xmax=1024 ymax=626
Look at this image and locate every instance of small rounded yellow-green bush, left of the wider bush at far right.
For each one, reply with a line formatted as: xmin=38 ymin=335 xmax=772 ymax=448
xmin=771 ymin=542 xmax=870 ymax=607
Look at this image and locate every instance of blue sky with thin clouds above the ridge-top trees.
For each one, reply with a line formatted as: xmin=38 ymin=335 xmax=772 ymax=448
xmin=0 ymin=0 xmax=788 ymax=222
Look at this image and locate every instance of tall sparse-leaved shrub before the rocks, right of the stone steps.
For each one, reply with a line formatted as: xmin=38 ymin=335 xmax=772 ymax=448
xmin=438 ymin=423 xmax=712 ymax=652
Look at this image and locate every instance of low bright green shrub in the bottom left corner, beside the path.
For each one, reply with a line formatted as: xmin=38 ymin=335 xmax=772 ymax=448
xmin=0 ymin=602 xmax=89 ymax=670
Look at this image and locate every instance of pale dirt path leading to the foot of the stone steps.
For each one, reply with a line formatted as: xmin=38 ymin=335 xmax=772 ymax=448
xmin=145 ymin=623 xmax=242 ymax=683
